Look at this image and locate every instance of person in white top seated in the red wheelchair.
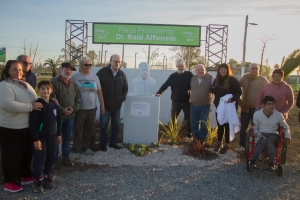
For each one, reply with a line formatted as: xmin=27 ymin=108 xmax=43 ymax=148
xmin=250 ymin=96 xmax=291 ymax=171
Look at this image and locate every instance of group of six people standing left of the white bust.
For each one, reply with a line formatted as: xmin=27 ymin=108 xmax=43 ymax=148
xmin=0 ymin=54 xmax=128 ymax=192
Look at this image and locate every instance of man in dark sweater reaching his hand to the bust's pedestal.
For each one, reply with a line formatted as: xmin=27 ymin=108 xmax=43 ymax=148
xmin=156 ymin=59 xmax=193 ymax=137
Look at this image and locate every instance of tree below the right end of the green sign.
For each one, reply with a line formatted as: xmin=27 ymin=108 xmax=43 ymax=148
xmin=169 ymin=46 xmax=205 ymax=70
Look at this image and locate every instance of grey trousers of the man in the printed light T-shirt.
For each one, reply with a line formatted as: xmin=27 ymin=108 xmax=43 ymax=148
xmin=72 ymin=107 xmax=97 ymax=153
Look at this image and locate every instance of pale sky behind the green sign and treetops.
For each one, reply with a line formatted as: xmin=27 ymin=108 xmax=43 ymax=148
xmin=0 ymin=0 xmax=300 ymax=67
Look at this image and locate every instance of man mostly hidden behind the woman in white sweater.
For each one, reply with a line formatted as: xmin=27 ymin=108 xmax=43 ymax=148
xmin=17 ymin=55 xmax=36 ymax=89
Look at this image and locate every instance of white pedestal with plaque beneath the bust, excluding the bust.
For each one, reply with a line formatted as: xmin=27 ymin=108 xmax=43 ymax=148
xmin=123 ymin=94 xmax=160 ymax=145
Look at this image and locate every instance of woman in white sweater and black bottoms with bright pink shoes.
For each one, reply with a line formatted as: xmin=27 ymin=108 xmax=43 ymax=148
xmin=0 ymin=60 xmax=42 ymax=192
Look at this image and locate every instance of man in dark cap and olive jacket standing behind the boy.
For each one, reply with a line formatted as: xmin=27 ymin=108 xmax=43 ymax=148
xmin=51 ymin=62 xmax=81 ymax=166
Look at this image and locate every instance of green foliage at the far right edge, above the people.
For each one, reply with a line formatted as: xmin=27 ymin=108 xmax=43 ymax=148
xmin=281 ymin=49 xmax=300 ymax=78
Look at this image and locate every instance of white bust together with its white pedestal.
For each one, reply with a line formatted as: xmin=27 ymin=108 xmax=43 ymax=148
xmin=123 ymin=62 xmax=160 ymax=145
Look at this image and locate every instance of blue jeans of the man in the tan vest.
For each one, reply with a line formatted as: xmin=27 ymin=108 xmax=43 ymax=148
xmin=190 ymin=104 xmax=210 ymax=140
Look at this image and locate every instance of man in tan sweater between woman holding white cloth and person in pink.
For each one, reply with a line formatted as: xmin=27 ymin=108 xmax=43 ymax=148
xmin=236 ymin=63 xmax=268 ymax=151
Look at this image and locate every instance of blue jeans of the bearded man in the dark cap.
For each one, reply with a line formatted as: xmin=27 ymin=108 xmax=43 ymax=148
xmin=56 ymin=117 xmax=74 ymax=159
